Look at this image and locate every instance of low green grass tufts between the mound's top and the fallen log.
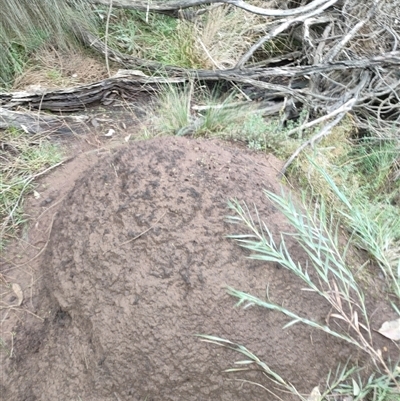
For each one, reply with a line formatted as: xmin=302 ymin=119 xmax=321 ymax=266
xmin=149 ymin=84 xmax=310 ymax=149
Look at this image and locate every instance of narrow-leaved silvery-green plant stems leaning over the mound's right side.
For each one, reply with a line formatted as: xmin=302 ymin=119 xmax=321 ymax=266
xmin=229 ymin=192 xmax=400 ymax=390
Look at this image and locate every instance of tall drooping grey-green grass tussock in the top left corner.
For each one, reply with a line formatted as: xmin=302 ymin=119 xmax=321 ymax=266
xmin=0 ymin=0 xmax=96 ymax=87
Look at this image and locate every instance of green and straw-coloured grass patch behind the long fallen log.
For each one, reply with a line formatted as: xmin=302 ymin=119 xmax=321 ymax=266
xmin=104 ymin=2 xmax=289 ymax=69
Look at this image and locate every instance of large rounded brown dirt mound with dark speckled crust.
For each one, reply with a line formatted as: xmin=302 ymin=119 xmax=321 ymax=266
xmin=3 ymin=138 xmax=349 ymax=401
